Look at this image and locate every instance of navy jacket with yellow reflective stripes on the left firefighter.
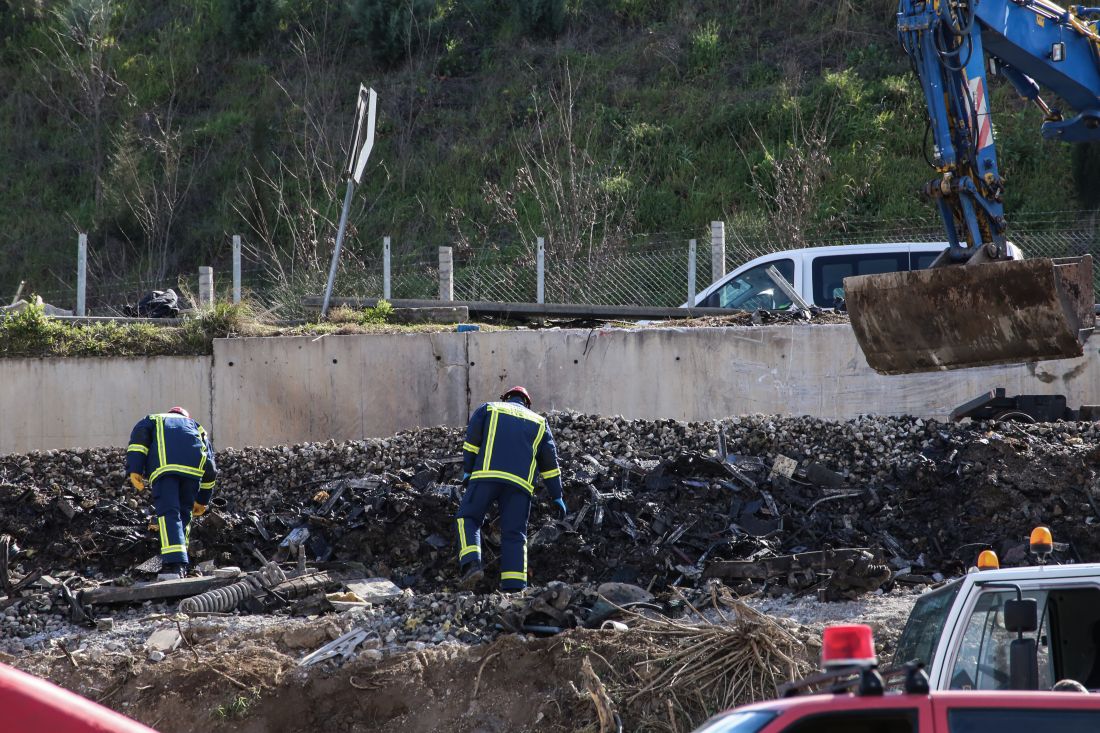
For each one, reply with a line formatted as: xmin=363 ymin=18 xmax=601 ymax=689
xmin=127 ymin=413 xmax=218 ymax=504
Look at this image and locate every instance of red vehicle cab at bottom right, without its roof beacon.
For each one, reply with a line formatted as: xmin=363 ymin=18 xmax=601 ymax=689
xmin=696 ymin=690 xmax=1100 ymax=733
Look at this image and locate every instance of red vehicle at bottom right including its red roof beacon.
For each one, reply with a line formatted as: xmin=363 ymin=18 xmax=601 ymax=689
xmin=696 ymin=626 xmax=1100 ymax=733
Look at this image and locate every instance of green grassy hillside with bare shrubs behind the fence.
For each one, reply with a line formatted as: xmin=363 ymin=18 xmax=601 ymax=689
xmin=0 ymin=0 xmax=1096 ymax=308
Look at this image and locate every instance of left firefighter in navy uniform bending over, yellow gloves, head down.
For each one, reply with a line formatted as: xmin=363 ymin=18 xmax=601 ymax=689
xmin=127 ymin=407 xmax=218 ymax=580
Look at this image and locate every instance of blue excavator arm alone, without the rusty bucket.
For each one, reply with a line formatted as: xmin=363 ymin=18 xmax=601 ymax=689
xmin=898 ymin=0 xmax=1100 ymax=264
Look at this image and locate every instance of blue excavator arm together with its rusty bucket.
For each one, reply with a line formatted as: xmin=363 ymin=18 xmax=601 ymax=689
xmin=845 ymin=0 xmax=1100 ymax=374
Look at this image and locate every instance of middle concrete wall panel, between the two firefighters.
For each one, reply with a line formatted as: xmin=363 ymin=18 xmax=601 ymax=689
xmin=213 ymin=333 xmax=466 ymax=447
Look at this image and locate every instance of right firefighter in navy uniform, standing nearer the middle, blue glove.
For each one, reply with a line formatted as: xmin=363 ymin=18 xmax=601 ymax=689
xmin=455 ymin=386 xmax=567 ymax=591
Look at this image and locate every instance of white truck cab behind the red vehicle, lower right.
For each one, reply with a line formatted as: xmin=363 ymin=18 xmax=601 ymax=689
xmin=894 ymin=534 xmax=1100 ymax=690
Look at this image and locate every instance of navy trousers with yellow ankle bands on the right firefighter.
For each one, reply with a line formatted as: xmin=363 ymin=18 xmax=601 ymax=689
xmin=455 ymin=481 xmax=531 ymax=591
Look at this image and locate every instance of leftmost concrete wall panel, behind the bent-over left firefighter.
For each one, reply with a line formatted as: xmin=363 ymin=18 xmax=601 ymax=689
xmin=0 ymin=357 xmax=212 ymax=455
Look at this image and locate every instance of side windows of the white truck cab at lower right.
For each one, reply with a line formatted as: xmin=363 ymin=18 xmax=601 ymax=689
xmin=950 ymin=587 xmax=1100 ymax=690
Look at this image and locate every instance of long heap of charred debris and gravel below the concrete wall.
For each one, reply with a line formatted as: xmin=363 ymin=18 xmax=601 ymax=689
xmin=0 ymin=414 xmax=1100 ymax=643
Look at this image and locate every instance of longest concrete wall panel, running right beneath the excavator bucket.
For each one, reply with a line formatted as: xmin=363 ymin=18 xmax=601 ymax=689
xmin=469 ymin=325 xmax=1100 ymax=420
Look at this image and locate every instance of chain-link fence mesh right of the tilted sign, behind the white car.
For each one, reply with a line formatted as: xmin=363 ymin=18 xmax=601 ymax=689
xmin=337 ymin=212 xmax=1100 ymax=307
